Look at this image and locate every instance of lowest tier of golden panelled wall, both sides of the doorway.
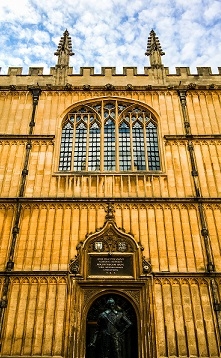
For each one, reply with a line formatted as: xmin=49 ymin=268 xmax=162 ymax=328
xmin=2 ymin=276 xmax=220 ymax=357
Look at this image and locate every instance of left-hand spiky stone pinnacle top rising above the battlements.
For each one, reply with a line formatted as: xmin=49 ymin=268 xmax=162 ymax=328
xmin=54 ymin=30 xmax=74 ymax=67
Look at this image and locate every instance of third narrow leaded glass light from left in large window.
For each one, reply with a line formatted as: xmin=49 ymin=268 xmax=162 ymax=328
xmin=88 ymin=122 xmax=101 ymax=170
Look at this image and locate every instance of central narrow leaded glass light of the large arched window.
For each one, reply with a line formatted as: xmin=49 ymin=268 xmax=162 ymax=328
xmin=104 ymin=119 xmax=115 ymax=170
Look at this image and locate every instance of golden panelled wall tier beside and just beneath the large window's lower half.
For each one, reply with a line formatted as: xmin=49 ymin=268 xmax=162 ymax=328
xmin=0 ymin=139 xmax=221 ymax=198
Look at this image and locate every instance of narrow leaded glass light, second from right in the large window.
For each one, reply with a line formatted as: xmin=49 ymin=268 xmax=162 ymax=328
xmin=132 ymin=122 xmax=146 ymax=170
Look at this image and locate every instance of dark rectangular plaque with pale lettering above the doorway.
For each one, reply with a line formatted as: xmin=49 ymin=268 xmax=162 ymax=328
xmin=89 ymin=255 xmax=133 ymax=276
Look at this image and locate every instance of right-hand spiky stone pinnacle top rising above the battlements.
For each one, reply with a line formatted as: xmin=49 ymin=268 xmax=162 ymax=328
xmin=145 ymin=30 xmax=165 ymax=68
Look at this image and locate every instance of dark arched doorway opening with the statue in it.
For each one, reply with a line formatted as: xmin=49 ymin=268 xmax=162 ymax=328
xmin=86 ymin=293 xmax=138 ymax=358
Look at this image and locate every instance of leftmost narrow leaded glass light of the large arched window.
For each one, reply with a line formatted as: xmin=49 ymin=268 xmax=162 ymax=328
xmin=59 ymin=122 xmax=73 ymax=170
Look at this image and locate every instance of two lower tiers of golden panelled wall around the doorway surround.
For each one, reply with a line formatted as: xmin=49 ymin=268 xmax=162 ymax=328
xmin=0 ymin=204 xmax=221 ymax=357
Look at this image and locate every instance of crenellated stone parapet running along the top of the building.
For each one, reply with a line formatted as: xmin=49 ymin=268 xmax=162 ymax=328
xmin=0 ymin=66 xmax=221 ymax=89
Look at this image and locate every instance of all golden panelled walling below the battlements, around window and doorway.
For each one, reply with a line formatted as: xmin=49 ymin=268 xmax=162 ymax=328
xmin=0 ymin=79 xmax=221 ymax=358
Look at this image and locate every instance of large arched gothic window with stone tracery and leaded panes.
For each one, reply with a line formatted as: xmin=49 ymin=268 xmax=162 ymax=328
xmin=59 ymin=100 xmax=160 ymax=172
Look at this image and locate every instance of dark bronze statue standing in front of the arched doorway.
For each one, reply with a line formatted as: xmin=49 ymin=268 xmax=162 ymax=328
xmin=90 ymin=298 xmax=132 ymax=358
